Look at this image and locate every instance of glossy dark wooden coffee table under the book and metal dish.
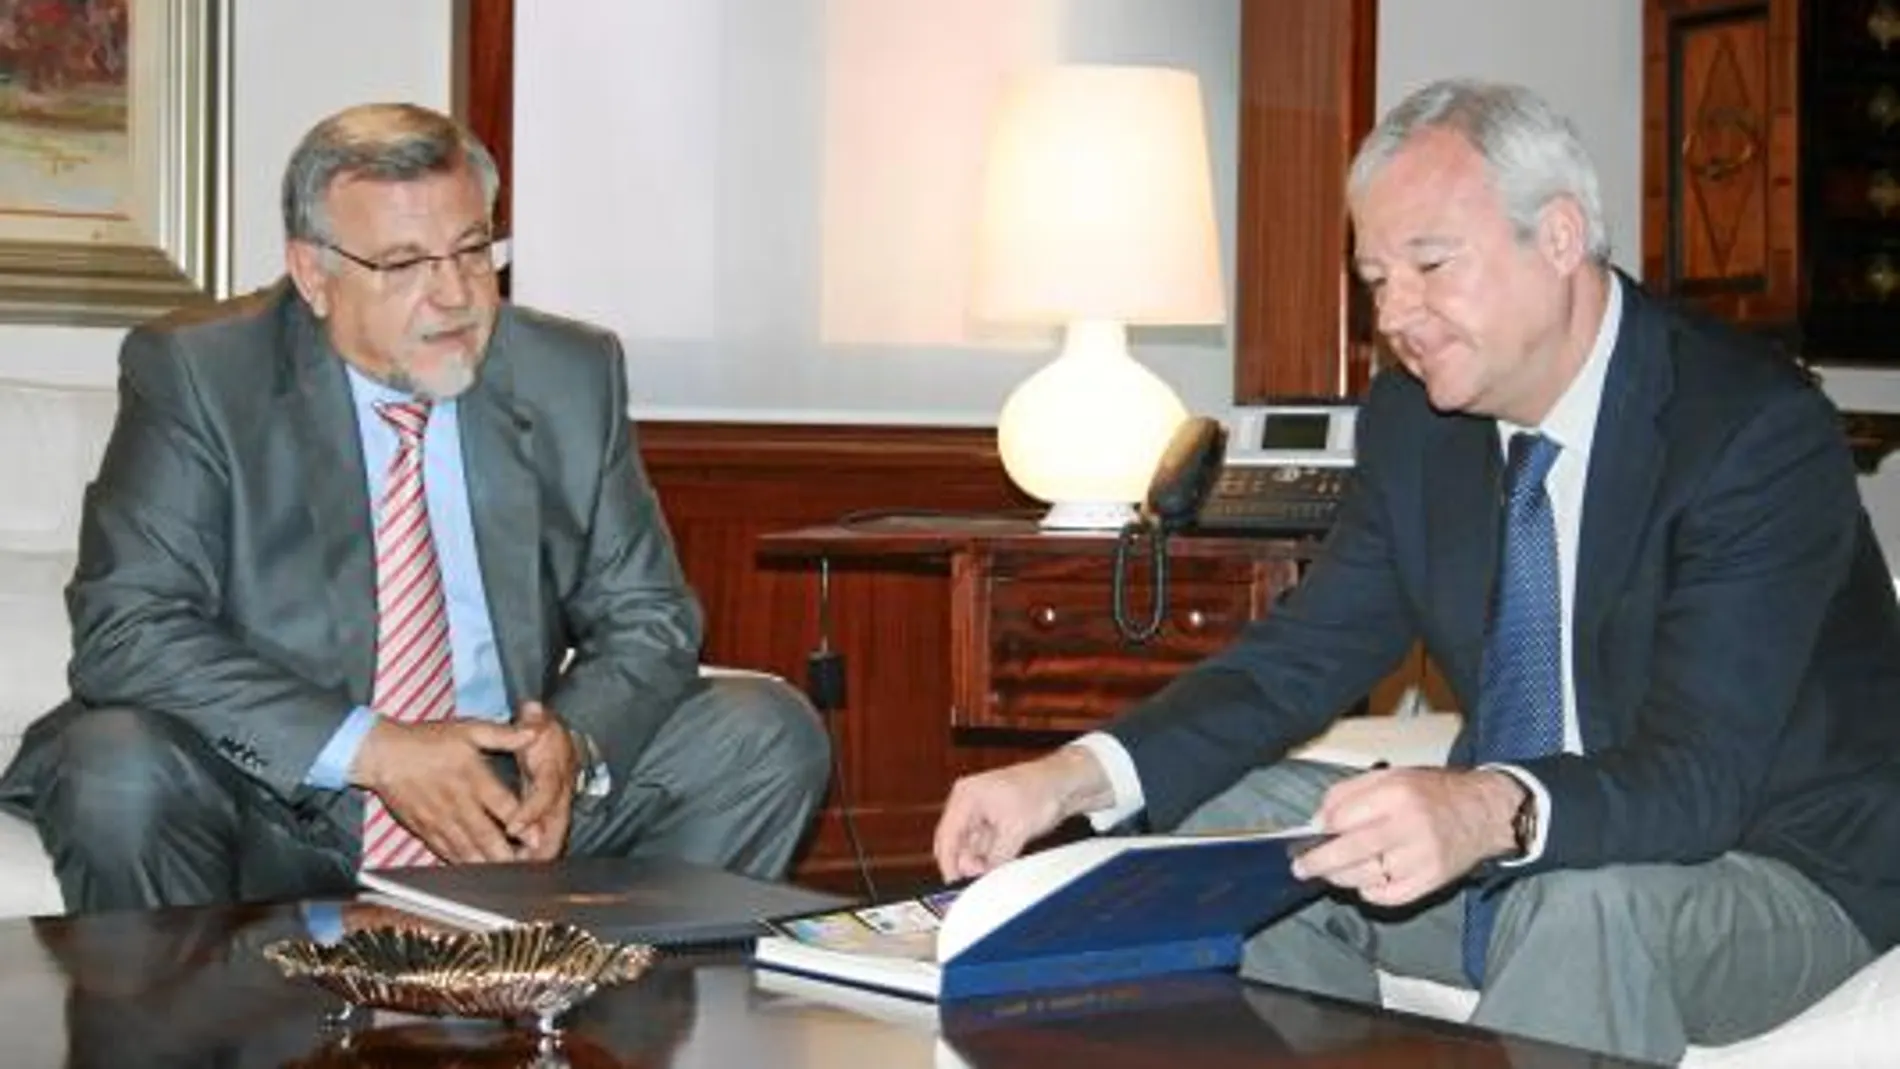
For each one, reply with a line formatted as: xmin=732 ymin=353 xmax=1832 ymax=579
xmin=0 ymin=906 xmax=1656 ymax=1069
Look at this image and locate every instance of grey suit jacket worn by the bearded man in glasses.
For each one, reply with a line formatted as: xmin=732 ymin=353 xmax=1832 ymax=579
xmin=8 ymin=283 xmax=701 ymax=826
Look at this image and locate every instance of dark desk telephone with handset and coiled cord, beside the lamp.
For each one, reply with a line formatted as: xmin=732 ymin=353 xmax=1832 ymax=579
xmin=1112 ymin=404 xmax=1359 ymax=644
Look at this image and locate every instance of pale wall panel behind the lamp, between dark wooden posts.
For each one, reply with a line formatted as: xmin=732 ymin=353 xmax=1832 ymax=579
xmin=513 ymin=0 xmax=1239 ymax=425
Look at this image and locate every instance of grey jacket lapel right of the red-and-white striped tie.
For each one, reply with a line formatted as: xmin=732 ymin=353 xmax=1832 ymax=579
xmin=460 ymin=309 xmax=545 ymax=704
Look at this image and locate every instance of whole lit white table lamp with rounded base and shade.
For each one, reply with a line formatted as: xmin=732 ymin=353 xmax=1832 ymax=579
xmin=975 ymin=66 xmax=1224 ymax=530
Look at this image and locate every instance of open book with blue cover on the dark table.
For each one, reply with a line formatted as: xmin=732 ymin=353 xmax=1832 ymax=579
xmin=754 ymin=826 xmax=1321 ymax=1001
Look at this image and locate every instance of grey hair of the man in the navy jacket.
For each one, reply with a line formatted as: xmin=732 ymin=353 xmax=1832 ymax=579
xmin=1345 ymin=78 xmax=1609 ymax=264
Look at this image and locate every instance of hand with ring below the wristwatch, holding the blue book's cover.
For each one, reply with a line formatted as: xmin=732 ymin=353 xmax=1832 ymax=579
xmin=1294 ymin=769 xmax=1524 ymax=906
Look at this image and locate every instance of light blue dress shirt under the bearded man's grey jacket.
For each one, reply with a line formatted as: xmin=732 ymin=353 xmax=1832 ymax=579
xmin=304 ymin=368 xmax=511 ymax=790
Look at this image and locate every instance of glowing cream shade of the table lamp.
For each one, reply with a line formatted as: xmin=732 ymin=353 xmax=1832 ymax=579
xmin=975 ymin=66 xmax=1226 ymax=323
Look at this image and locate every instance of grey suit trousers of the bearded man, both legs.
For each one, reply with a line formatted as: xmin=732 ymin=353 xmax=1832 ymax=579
xmin=11 ymin=678 xmax=830 ymax=911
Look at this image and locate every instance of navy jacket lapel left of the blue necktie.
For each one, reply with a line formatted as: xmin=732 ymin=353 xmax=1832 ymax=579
xmin=1425 ymin=416 xmax=1499 ymax=708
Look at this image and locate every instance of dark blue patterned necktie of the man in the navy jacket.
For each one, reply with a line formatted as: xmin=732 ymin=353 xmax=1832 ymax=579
xmin=1463 ymin=433 xmax=1564 ymax=987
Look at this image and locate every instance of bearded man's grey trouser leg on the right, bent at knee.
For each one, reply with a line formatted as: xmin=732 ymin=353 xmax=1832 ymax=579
xmin=568 ymin=676 xmax=830 ymax=879
